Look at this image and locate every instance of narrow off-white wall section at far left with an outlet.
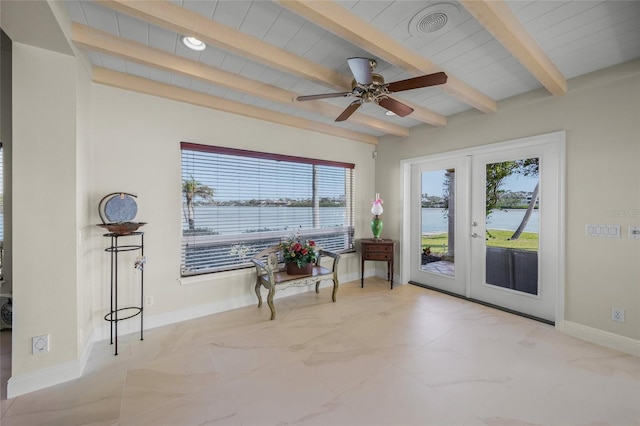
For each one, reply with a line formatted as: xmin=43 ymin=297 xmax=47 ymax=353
xmin=10 ymin=43 xmax=78 ymax=376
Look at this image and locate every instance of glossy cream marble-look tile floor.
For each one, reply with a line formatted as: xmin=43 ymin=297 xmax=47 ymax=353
xmin=0 ymin=278 xmax=640 ymax=426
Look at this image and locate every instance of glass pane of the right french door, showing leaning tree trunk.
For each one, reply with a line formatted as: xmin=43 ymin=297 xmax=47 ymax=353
xmin=485 ymin=158 xmax=540 ymax=295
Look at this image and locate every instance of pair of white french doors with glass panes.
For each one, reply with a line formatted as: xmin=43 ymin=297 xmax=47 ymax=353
xmin=407 ymin=132 xmax=564 ymax=322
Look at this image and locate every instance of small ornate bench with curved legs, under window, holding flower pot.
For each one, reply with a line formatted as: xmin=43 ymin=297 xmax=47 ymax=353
xmin=251 ymin=246 xmax=340 ymax=320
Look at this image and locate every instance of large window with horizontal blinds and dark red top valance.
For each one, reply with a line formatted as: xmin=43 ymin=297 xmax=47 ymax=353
xmin=181 ymin=142 xmax=355 ymax=277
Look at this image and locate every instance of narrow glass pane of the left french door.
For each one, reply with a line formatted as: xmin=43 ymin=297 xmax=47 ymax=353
xmin=420 ymin=169 xmax=456 ymax=276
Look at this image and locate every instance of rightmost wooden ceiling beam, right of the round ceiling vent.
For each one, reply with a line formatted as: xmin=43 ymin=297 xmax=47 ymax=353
xmin=460 ymin=0 xmax=567 ymax=96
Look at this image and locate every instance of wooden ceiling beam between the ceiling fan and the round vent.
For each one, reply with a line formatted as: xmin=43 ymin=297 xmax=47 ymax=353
xmin=276 ymin=0 xmax=497 ymax=112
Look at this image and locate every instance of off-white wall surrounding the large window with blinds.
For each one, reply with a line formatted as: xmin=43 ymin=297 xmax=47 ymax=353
xmin=89 ymin=84 xmax=375 ymax=337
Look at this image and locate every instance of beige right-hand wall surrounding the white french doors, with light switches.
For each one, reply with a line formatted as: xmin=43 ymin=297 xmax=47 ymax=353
xmin=376 ymin=61 xmax=640 ymax=346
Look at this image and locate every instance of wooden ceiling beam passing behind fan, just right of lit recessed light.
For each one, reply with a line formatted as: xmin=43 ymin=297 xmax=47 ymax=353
xmin=96 ymin=0 xmax=447 ymax=126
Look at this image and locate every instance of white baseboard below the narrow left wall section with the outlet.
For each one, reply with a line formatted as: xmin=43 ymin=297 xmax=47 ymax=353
xmin=7 ymin=335 xmax=95 ymax=398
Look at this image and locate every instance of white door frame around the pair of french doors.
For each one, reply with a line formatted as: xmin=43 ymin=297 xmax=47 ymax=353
xmin=399 ymin=131 xmax=566 ymax=328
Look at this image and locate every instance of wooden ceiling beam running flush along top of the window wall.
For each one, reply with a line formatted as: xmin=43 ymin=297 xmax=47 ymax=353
xmin=92 ymin=67 xmax=378 ymax=145
